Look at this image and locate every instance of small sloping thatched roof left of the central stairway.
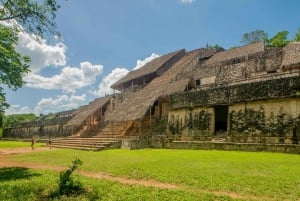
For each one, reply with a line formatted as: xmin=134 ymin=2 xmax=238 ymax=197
xmin=66 ymin=96 xmax=112 ymax=126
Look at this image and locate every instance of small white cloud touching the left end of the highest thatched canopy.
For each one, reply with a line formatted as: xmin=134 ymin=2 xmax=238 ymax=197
xmin=92 ymin=68 xmax=129 ymax=97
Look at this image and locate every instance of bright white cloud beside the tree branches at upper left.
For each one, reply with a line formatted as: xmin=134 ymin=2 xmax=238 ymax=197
xmin=16 ymin=32 xmax=67 ymax=72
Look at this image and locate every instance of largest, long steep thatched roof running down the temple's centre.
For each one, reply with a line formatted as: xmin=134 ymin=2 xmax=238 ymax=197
xmin=105 ymin=50 xmax=203 ymax=122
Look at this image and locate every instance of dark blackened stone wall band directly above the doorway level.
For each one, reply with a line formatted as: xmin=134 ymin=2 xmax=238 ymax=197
xmin=170 ymin=76 xmax=300 ymax=109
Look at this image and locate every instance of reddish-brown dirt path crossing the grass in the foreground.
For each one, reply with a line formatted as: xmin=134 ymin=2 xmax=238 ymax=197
xmin=0 ymin=147 xmax=272 ymax=200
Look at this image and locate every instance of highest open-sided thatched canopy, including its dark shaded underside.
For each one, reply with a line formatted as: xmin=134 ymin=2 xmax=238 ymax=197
xmin=111 ymin=49 xmax=185 ymax=91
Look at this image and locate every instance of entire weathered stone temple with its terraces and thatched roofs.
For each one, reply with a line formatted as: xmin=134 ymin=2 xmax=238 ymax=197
xmin=5 ymin=42 xmax=300 ymax=153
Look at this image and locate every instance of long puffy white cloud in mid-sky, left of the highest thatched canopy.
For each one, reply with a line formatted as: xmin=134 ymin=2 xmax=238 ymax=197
xmin=24 ymin=62 xmax=103 ymax=93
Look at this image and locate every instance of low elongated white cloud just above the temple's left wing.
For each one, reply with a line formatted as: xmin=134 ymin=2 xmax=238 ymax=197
xmin=34 ymin=94 xmax=86 ymax=115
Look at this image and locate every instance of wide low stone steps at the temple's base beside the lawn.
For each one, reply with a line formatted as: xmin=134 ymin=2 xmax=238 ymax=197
xmin=51 ymin=136 xmax=122 ymax=151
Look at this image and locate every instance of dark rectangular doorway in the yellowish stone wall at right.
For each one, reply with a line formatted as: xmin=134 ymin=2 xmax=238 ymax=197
xmin=215 ymin=105 xmax=228 ymax=135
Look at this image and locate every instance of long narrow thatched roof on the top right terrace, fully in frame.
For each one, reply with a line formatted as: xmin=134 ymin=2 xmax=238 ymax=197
xmin=205 ymin=42 xmax=265 ymax=65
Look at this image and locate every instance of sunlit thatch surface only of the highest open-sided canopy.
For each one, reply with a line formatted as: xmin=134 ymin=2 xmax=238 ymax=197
xmin=111 ymin=49 xmax=185 ymax=89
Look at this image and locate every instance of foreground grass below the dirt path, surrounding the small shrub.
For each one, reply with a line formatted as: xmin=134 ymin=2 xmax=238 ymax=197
xmin=0 ymin=168 xmax=237 ymax=201
